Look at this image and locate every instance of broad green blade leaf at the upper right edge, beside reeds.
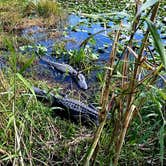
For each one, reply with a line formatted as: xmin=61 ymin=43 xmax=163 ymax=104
xmin=146 ymin=19 xmax=166 ymax=69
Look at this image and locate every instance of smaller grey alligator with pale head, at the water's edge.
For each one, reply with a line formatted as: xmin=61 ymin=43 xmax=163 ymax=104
xmin=41 ymin=57 xmax=88 ymax=90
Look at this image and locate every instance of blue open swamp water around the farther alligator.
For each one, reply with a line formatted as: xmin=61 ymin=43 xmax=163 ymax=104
xmin=19 ymin=14 xmax=165 ymax=90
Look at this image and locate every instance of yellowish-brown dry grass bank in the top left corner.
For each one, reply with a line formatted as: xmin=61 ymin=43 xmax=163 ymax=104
xmin=0 ymin=0 xmax=65 ymax=32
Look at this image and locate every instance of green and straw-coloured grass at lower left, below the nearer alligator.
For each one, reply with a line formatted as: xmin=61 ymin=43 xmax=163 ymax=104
xmin=0 ymin=40 xmax=92 ymax=165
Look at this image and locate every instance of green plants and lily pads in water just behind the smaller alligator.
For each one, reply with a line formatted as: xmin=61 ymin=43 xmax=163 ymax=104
xmin=52 ymin=38 xmax=100 ymax=73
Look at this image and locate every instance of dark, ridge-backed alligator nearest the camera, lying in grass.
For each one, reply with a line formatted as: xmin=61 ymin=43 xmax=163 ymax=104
xmin=33 ymin=87 xmax=99 ymax=125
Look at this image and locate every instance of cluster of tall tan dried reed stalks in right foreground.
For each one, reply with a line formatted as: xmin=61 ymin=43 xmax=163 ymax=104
xmin=84 ymin=0 xmax=165 ymax=166
